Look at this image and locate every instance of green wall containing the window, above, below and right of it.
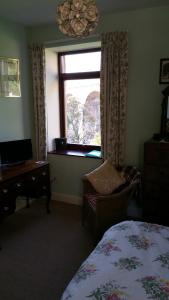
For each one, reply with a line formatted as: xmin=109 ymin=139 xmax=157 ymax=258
xmin=26 ymin=6 xmax=169 ymax=195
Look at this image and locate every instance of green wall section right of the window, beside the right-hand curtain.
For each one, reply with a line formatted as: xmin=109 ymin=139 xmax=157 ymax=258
xmin=99 ymin=6 xmax=169 ymax=167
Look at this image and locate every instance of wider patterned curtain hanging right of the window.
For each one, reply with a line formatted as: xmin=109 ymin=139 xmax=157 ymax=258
xmin=100 ymin=32 xmax=128 ymax=165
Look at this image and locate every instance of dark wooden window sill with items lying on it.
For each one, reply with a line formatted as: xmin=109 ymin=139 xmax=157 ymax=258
xmin=48 ymin=149 xmax=102 ymax=159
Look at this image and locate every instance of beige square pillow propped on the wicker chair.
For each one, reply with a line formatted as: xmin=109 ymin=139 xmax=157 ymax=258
xmin=86 ymin=160 xmax=125 ymax=195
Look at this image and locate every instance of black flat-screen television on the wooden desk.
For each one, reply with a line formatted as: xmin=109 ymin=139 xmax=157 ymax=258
xmin=0 ymin=139 xmax=33 ymax=167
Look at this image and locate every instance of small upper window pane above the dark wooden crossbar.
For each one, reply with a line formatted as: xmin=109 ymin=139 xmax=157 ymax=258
xmin=62 ymin=51 xmax=101 ymax=73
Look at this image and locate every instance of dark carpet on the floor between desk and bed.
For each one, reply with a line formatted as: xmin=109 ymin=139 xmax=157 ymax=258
xmin=0 ymin=199 xmax=93 ymax=300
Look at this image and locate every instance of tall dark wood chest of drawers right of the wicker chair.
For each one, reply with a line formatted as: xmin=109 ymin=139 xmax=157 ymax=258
xmin=143 ymin=140 xmax=169 ymax=225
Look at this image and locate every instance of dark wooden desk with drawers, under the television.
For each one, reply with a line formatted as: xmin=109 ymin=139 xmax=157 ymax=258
xmin=0 ymin=160 xmax=51 ymax=220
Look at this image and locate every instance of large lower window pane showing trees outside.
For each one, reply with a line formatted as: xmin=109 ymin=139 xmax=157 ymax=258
xmin=64 ymin=79 xmax=101 ymax=146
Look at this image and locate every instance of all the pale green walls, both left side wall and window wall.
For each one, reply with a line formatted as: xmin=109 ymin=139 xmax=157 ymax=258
xmin=0 ymin=6 xmax=169 ymax=196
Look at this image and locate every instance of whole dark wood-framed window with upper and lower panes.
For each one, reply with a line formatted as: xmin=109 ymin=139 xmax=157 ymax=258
xmin=58 ymin=49 xmax=101 ymax=148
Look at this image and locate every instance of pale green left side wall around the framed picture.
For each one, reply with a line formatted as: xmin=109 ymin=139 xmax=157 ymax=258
xmin=0 ymin=19 xmax=33 ymax=141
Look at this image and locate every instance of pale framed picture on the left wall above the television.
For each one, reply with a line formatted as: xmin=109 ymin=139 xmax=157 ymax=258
xmin=0 ymin=57 xmax=21 ymax=98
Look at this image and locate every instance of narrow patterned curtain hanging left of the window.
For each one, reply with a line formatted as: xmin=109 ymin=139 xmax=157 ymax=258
xmin=30 ymin=45 xmax=47 ymax=160
